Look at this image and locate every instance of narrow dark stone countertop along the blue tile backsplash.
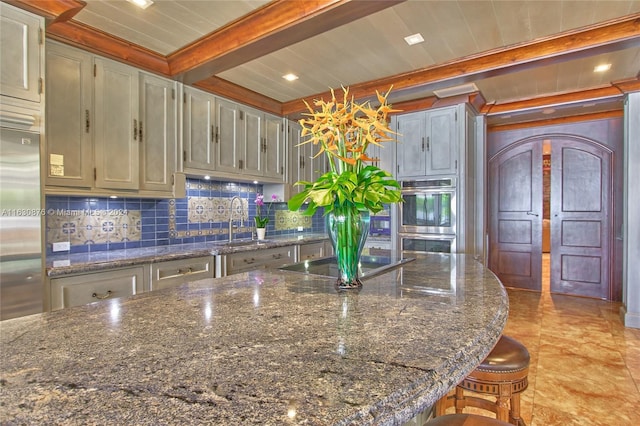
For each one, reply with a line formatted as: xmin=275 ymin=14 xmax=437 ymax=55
xmin=46 ymin=234 xmax=328 ymax=277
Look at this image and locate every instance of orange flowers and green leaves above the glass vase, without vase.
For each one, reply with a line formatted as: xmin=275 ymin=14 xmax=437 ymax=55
xmin=288 ymin=87 xmax=401 ymax=215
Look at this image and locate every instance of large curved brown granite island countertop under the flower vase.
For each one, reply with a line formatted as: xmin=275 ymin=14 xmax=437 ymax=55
xmin=0 ymin=254 xmax=508 ymax=425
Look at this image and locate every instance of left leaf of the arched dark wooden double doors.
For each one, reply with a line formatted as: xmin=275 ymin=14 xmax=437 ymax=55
xmin=489 ymin=141 xmax=542 ymax=290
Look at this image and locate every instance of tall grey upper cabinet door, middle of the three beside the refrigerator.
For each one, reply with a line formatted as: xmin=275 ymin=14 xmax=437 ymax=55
xmin=93 ymin=57 xmax=140 ymax=189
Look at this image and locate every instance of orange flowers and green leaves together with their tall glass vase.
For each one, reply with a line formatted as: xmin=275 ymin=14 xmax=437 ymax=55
xmin=288 ymin=87 xmax=401 ymax=290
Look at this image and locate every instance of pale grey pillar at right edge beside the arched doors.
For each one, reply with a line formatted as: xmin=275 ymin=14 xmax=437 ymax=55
xmin=620 ymin=92 xmax=640 ymax=328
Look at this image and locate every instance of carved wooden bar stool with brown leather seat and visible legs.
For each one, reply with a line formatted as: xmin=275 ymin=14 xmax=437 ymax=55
xmin=435 ymin=335 xmax=530 ymax=426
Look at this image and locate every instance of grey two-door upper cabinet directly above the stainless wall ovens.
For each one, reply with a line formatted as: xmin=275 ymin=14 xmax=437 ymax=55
xmin=396 ymin=106 xmax=460 ymax=180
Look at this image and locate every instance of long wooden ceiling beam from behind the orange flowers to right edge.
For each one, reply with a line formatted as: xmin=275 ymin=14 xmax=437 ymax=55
xmin=282 ymin=14 xmax=640 ymax=115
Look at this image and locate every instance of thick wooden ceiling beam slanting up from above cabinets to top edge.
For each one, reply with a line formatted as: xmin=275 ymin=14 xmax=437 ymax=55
xmin=167 ymin=0 xmax=405 ymax=84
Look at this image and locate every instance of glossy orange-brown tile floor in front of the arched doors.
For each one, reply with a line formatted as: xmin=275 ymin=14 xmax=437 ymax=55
xmin=440 ymin=255 xmax=640 ymax=426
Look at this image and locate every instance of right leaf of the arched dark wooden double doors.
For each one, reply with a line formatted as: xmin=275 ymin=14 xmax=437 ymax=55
xmin=551 ymin=140 xmax=611 ymax=299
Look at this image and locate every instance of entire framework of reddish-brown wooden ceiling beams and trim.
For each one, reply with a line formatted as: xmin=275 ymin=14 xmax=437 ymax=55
xmin=4 ymin=0 xmax=640 ymax=120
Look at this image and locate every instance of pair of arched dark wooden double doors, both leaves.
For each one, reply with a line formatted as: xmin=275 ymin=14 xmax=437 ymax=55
xmin=489 ymin=135 xmax=612 ymax=299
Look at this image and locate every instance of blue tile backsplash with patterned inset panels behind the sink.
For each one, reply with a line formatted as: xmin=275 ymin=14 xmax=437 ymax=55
xmin=46 ymin=179 xmax=324 ymax=255
